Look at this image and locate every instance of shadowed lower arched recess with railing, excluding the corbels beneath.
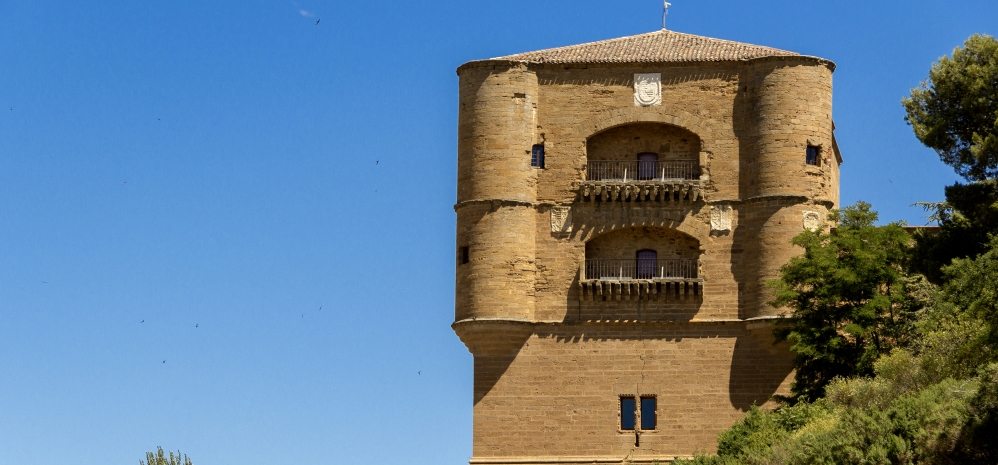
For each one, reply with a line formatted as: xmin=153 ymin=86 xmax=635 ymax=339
xmin=583 ymin=226 xmax=701 ymax=279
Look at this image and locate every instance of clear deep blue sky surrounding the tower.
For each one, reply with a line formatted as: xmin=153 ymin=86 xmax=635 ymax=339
xmin=0 ymin=0 xmax=998 ymax=465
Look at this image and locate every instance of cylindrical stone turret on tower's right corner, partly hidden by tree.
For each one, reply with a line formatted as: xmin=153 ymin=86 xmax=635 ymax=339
xmin=740 ymin=59 xmax=837 ymax=318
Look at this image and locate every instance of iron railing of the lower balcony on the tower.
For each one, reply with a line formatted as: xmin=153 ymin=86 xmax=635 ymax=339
xmin=585 ymin=258 xmax=699 ymax=280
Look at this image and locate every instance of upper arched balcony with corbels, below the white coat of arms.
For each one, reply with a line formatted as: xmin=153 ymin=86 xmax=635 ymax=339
xmin=579 ymin=123 xmax=702 ymax=202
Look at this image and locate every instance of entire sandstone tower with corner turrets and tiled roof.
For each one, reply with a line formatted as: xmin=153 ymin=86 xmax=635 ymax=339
xmin=453 ymin=29 xmax=841 ymax=464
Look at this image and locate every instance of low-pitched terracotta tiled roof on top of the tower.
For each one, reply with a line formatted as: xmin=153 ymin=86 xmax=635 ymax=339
xmin=492 ymin=29 xmax=801 ymax=63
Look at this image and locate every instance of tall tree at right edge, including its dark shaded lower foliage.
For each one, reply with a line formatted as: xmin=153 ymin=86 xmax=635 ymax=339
xmin=902 ymin=35 xmax=998 ymax=283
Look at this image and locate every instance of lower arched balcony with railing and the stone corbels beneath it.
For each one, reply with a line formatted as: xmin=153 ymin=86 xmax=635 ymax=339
xmin=579 ymin=227 xmax=703 ymax=300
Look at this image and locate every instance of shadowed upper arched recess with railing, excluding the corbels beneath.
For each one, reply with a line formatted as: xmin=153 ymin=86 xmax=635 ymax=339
xmin=586 ymin=122 xmax=702 ymax=181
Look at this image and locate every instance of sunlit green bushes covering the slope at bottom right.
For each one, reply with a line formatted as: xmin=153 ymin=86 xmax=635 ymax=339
xmin=680 ymin=239 xmax=998 ymax=465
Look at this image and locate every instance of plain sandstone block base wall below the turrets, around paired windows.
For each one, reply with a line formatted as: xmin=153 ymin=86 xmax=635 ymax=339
xmin=474 ymin=323 xmax=791 ymax=463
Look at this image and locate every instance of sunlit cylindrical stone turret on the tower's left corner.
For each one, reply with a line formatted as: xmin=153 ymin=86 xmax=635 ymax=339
xmin=455 ymin=64 xmax=540 ymax=321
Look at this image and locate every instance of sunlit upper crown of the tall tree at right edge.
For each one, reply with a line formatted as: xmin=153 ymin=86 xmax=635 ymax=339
xmin=902 ymin=35 xmax=998 ymax=181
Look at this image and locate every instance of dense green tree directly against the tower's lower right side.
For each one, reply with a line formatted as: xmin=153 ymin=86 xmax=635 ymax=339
xmin=772 ymin=202 xmax=922 ymax=401
